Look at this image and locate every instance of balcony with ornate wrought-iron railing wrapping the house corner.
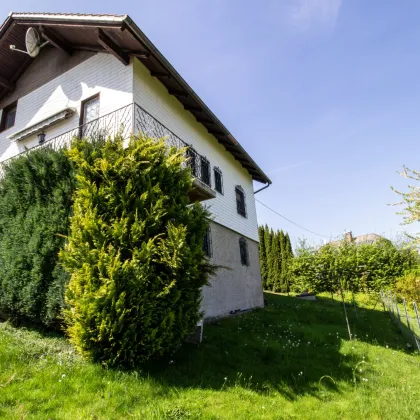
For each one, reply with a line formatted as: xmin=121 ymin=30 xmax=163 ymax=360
xmin=0 ymin=103 xmax=216 ymax=201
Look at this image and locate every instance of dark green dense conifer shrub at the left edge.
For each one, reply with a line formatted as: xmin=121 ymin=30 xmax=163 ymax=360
xmin=0 ymin=148 xmax=74 ymax=327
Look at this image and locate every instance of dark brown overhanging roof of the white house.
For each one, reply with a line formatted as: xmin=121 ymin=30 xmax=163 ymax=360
xmin=0 ymin=13 xmax=271 ymax=184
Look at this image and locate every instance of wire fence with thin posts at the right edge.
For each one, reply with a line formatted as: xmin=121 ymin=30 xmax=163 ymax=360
xmin=380 ymin=291 xmax=420 ymax=351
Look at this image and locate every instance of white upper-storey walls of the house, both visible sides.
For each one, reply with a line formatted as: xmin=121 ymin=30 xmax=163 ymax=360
xmin=0 ymin=53 xmax=258 ymax=241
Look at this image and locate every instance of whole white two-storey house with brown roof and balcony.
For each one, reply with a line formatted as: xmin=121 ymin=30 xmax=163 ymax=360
xmin=0 ymin=13 xmax=270 ymax=318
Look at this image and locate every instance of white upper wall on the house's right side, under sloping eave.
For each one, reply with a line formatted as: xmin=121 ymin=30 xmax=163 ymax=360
xmin=133 ymin=59 xmax=258 ymax=241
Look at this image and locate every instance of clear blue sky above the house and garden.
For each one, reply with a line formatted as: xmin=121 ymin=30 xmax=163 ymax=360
xmin=0 ymin=0 xmax=420 ymax=243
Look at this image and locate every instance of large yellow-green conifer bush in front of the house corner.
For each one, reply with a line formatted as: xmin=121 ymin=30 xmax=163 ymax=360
xmin=60 ymin=138 xmax=213 ymax=367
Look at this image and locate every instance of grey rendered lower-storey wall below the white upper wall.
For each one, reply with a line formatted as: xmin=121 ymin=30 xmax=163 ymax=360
xmin=202 ymin=222 xmax=264 ymax=318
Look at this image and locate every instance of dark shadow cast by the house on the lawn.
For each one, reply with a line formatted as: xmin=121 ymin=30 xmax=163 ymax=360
xmin=142 ymin=294 xmax=405 ymax=400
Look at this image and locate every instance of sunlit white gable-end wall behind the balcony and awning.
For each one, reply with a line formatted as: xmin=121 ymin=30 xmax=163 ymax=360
xmin=0 ymin=53 xmax=133 ymax=160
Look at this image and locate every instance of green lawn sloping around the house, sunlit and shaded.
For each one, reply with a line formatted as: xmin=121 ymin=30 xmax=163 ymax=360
xmin=0 ymin=294 xmax=420 ymax=419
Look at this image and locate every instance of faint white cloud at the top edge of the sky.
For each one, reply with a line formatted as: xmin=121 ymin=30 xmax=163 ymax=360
xmin=290 ymin=0 xmax=342 ymax=30
